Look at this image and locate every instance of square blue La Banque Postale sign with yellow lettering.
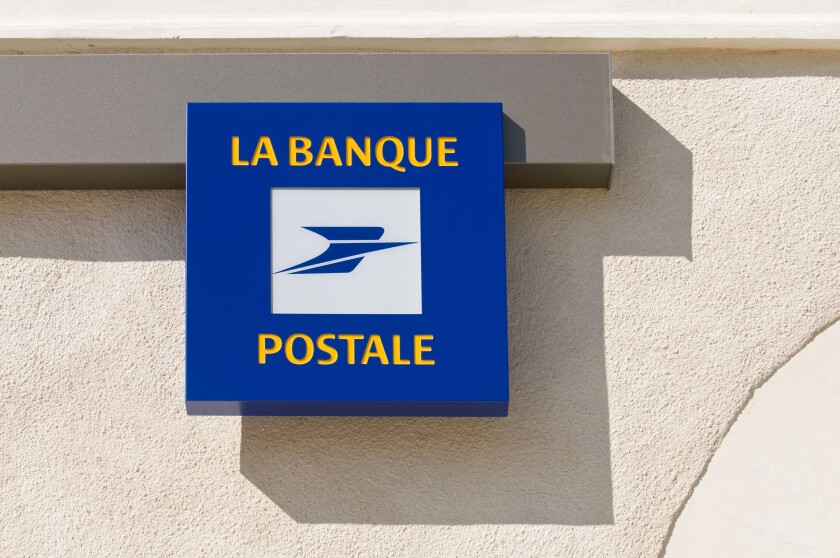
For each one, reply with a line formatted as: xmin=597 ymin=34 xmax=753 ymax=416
xmin=186 ymin=103 xmax=508 ymax=416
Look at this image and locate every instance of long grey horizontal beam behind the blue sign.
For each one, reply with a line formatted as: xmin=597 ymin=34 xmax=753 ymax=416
xmin=0 ymin=54 xmax=614 ymax=189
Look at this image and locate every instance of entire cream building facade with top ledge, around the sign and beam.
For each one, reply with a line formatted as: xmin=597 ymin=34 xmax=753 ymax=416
xmin=0 ymin=0 xmax=840 ymax=557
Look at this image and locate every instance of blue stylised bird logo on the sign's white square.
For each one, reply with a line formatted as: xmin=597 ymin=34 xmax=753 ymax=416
xmin=274 ymin=227 xmax=417 ymax=275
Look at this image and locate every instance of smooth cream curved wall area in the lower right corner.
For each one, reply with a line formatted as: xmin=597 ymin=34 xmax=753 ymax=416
xmin=666 ymin=322 xmax=840 ymax=558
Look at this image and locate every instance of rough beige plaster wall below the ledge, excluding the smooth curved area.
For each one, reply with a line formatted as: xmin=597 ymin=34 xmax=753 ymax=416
xmin=0 ymin=52 xmax=840 ymax=557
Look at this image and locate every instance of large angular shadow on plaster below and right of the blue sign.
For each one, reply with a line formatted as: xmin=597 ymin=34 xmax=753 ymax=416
xmin=240 ymin=91 xmax=692 ymax=525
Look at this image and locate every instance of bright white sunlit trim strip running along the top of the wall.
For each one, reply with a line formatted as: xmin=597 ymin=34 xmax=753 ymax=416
xmin=0 ymin=12 xmax=840 ymax=40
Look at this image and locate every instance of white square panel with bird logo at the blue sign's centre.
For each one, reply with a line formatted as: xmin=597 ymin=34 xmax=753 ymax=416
xmin=271 ymin=188 xmax=423 ymax=314
